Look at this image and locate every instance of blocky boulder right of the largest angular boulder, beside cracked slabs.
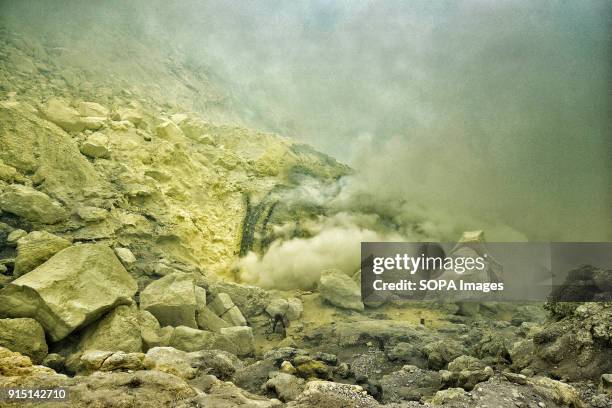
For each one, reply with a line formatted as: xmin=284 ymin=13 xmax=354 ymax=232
xmin=140 ymin=273 xmax=198 ymax=329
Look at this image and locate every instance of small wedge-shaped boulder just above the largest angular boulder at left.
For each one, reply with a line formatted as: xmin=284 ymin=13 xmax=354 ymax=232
xmin=13 ymin=231 xmax=70 ymax=277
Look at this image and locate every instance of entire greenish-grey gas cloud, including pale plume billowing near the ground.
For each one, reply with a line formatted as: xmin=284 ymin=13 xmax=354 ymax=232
xmin=0 ymin=0 xmax=612 ymax=287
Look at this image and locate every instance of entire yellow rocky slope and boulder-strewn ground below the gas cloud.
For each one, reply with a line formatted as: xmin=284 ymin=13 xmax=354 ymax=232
xmin=0 ymin=18 xmax=612 ymax=408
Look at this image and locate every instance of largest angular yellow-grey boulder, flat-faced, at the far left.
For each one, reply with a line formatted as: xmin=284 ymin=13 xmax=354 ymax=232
xmin=0 ymin=244 xmax=137 ymax=341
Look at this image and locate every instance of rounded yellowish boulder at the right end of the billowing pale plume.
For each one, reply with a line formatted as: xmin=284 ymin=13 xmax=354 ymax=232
xmin=319 ymin=270 xmax=364 ymax=311
